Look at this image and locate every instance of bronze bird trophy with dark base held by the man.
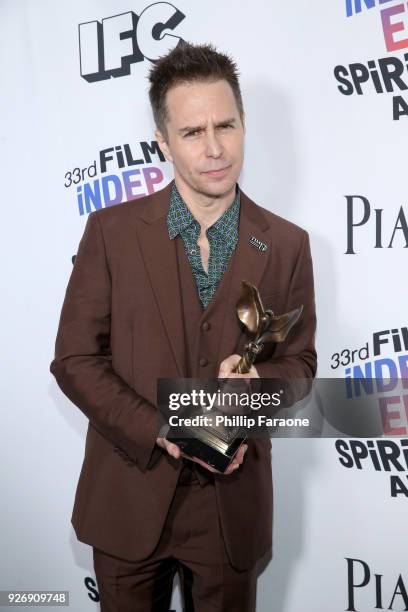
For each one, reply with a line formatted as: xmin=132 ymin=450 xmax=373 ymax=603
xmin=166 ymin=281 xmax=303 ymax=472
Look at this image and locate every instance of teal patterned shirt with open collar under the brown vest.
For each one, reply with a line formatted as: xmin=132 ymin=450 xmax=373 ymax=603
xmin=167 ymin=183 xmax=240 ymax=308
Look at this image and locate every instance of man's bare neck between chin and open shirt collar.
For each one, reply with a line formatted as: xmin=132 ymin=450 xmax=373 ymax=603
xmin=174 ymin=177 xmax=236 ymax=230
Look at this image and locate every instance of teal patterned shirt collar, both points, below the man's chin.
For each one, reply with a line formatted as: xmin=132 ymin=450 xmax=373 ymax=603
xmin=167 ymin=182 xmax=240 ymax=243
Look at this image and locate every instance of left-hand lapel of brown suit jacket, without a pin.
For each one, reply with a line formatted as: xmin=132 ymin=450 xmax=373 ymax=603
xmin=133 ymin=182 xmax=186 ymax=378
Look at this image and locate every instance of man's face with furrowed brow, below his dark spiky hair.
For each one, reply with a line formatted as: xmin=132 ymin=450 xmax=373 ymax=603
xmin=156 ymin=80 xmax=244 ymax=198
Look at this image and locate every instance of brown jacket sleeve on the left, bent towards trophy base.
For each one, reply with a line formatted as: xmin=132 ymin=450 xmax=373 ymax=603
xmin=50 ymin=212 xmax=161 ymax=471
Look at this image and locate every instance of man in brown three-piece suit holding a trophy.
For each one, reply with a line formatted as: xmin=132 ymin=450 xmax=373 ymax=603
xmin=51 ymin=43 xmax=316 ymax=612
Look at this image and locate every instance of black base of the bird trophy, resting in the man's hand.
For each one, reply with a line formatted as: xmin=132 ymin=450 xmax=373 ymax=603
xmin=166 ymin=427 xmax=247 ymax=472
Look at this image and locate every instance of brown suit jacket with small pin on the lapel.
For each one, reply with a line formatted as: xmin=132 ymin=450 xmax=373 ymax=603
xmin=50 ymin=183 xmax=316 ymax=570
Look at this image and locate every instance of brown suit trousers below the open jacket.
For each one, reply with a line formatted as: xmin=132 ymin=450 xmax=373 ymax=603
xmin=93 ymin=461 xmax=257 ymax=612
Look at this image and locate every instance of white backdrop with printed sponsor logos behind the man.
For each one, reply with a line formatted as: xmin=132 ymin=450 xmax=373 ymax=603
xmin=0 ymin=0 xmax=408 ymax=612
